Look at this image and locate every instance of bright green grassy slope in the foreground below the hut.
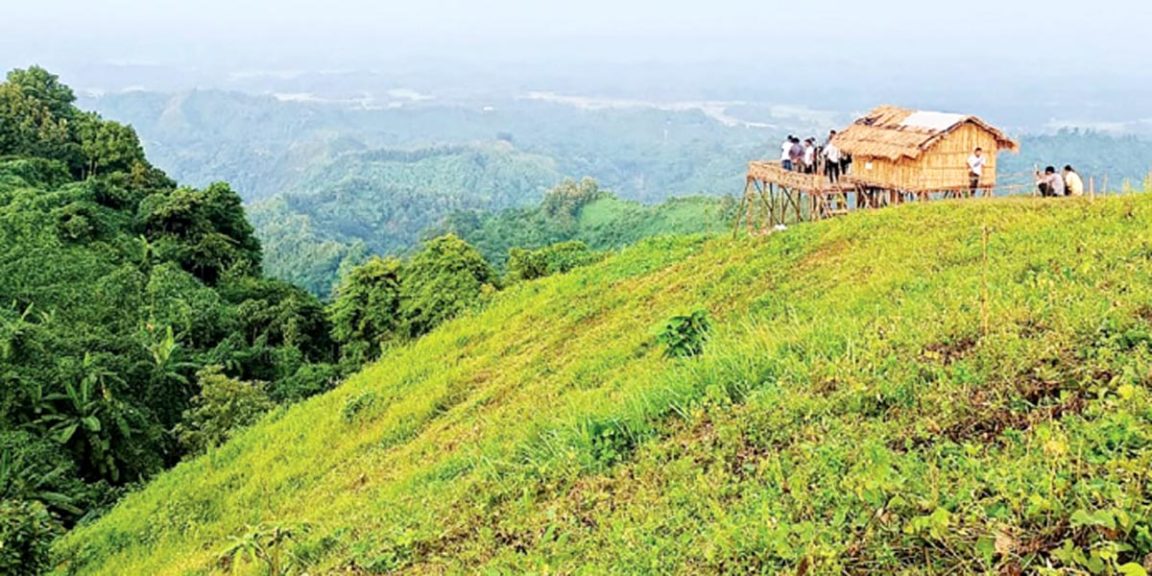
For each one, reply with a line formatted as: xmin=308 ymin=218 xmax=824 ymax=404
xmin=56 ymin=196 xmax=1152 ymax=575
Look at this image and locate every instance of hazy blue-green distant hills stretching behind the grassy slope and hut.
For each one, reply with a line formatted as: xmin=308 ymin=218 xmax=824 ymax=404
xmin=91 ymin=91 xmax=1152 ymax=296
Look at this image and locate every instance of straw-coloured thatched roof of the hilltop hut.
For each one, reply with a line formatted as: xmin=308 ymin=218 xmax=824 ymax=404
xmin=833 ymin=106 xmax=1020 ymax=160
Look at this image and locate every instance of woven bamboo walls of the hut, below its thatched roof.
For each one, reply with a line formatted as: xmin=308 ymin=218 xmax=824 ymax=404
xmin=851 ymin=123 xmax=998 ymax=192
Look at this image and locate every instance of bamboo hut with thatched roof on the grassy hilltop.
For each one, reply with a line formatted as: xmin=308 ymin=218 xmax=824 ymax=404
xmin=833 ymin=106 xmax=1020 ymax=196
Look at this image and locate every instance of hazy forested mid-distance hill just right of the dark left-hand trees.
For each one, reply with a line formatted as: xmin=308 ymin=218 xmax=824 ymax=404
xmin=250 ymin=143 xmax=561 ymax=297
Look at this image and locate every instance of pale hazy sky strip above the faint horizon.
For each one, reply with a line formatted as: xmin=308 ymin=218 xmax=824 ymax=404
xmin=0 ymin=0 xmax=1152 ymax=68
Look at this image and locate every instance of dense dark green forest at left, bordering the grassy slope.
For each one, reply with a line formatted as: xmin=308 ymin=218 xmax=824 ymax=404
xmin=0 ymin=68 xmax=597 ymax=575
